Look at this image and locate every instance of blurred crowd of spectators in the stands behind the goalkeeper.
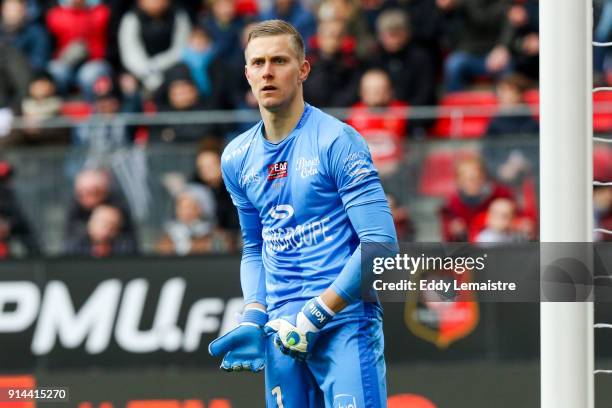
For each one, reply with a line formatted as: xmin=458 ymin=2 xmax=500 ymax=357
xmin=0 ymin=0 xmax=612 ymax=258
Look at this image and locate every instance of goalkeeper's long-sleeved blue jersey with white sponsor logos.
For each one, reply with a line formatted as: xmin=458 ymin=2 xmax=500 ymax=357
xmin=222 ymin=104 xmax=396 ymax=311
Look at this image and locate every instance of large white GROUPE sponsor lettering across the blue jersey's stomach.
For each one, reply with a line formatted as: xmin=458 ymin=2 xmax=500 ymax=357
xmin=261 ymin=217 xmax=332 ymax=252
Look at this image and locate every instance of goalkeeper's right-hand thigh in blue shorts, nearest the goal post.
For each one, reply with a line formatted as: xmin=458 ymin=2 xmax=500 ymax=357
xmin=308 ymin=317 xmax=387 ymax=408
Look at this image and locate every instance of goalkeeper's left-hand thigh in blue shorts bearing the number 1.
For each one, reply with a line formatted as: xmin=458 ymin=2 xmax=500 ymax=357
xmin=265 ymin=336 xmax=323 ymax=408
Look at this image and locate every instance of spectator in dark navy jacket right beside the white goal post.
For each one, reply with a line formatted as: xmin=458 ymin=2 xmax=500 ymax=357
xmin=484 ymin=74 xmax=539 ymax=185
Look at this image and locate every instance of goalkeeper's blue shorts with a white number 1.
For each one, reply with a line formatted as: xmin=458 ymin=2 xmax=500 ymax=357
xmin=265 ymin=303 xmax=387 ymax=408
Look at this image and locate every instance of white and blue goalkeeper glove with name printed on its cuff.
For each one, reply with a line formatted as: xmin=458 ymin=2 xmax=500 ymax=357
xmin=265 ymin=297 xmax=335 ymax=361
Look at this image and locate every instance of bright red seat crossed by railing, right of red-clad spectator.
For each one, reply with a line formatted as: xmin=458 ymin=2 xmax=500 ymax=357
xmin=432 ymin=91 xmax=497 ymax=138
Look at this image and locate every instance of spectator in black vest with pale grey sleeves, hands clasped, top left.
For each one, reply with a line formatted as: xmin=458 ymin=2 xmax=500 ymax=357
xmin=119 ymin=0 xmax=191 ymax=92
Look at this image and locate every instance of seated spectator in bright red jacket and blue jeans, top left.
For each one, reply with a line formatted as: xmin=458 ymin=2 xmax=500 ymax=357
xmin=47 ymin=0 xmax=111 ymax=99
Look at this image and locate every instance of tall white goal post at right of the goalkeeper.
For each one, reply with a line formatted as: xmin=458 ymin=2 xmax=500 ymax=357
xmin=540 ymin=0 xmax=594 ymax=408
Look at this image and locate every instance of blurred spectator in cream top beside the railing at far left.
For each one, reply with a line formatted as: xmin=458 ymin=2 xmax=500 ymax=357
xmin=15 ymin=72 xmax=70 ymax=144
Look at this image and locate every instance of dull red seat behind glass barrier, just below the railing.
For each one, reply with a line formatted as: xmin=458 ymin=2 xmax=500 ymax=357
xmin=419 ymin=149 xmax=476 ymax=197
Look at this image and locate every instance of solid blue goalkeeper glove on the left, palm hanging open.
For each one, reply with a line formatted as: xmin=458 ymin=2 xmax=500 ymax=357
xmin=208 ymin=308 xmax=268 ymax=373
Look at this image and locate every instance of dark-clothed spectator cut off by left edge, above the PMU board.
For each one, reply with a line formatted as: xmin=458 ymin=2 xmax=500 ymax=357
xmin=0 ymin=161 xmax=39 ymax=259
